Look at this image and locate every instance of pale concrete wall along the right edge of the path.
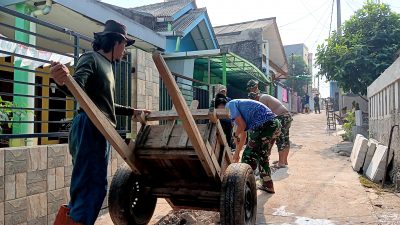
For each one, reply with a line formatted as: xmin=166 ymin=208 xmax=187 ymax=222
xmin=368 ymin=58 xmax=400 ymax=191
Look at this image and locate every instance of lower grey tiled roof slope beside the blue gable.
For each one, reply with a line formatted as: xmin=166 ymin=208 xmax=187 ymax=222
xmin=156 ymin=8 xmax=207 ymax=32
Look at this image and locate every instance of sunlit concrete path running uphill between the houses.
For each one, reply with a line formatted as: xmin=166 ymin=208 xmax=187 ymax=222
xmin=96 ymin=112 xmax=400 ymax=225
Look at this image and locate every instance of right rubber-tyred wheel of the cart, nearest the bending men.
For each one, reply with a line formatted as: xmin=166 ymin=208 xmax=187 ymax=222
xmin=220 ymin=163 xmax=257 ymax=225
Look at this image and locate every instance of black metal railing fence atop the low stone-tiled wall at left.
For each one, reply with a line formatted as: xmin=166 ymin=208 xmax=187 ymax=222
xmin=0 ymin=7 xmax=132 ymax=147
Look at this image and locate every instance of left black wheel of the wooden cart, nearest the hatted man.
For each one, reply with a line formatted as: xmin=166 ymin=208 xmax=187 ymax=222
xmin=108 ymin=164 xmax=157 ymax=225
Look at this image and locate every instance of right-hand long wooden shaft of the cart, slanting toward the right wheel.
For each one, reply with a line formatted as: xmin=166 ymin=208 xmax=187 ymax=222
xmin=153 ymin=52 xmax=216 ymax=176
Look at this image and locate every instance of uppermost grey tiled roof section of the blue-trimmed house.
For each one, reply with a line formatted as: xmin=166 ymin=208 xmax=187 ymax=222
xmin=132 ymin=0 xmax=194 ymax=17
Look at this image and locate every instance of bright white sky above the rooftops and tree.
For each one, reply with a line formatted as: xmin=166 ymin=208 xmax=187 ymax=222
xmin=103 ymin=0 xmax=400 ymax=97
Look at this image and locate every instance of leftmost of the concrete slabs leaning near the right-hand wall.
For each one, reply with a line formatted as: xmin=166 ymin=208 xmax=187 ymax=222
xmin=350 ymin=134 xmax=368 ymax=172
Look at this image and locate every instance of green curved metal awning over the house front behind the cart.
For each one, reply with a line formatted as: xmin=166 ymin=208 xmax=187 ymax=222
xmin=164 ymin=49 xmax=271 ymax=90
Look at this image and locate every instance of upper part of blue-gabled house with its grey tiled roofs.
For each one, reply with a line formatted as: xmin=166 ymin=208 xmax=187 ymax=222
xmin=102 ymin=0 xmax=218 ymax=51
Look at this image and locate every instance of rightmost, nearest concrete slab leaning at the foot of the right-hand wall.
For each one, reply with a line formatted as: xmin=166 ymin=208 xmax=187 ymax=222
xmin=365 ymin=145 xmax=393 ymax=182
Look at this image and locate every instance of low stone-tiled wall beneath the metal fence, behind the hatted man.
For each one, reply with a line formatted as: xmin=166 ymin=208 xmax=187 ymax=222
xmin=0 ymin=145 xmax=123 ymax=225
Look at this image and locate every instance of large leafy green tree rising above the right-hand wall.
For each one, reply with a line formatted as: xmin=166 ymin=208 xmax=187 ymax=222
xmin=316 ymin=1 xmax=400 ymax=95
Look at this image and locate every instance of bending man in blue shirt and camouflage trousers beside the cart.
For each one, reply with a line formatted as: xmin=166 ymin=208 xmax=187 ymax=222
xmin=226 ymin=99 xmax=281 ymax=193
